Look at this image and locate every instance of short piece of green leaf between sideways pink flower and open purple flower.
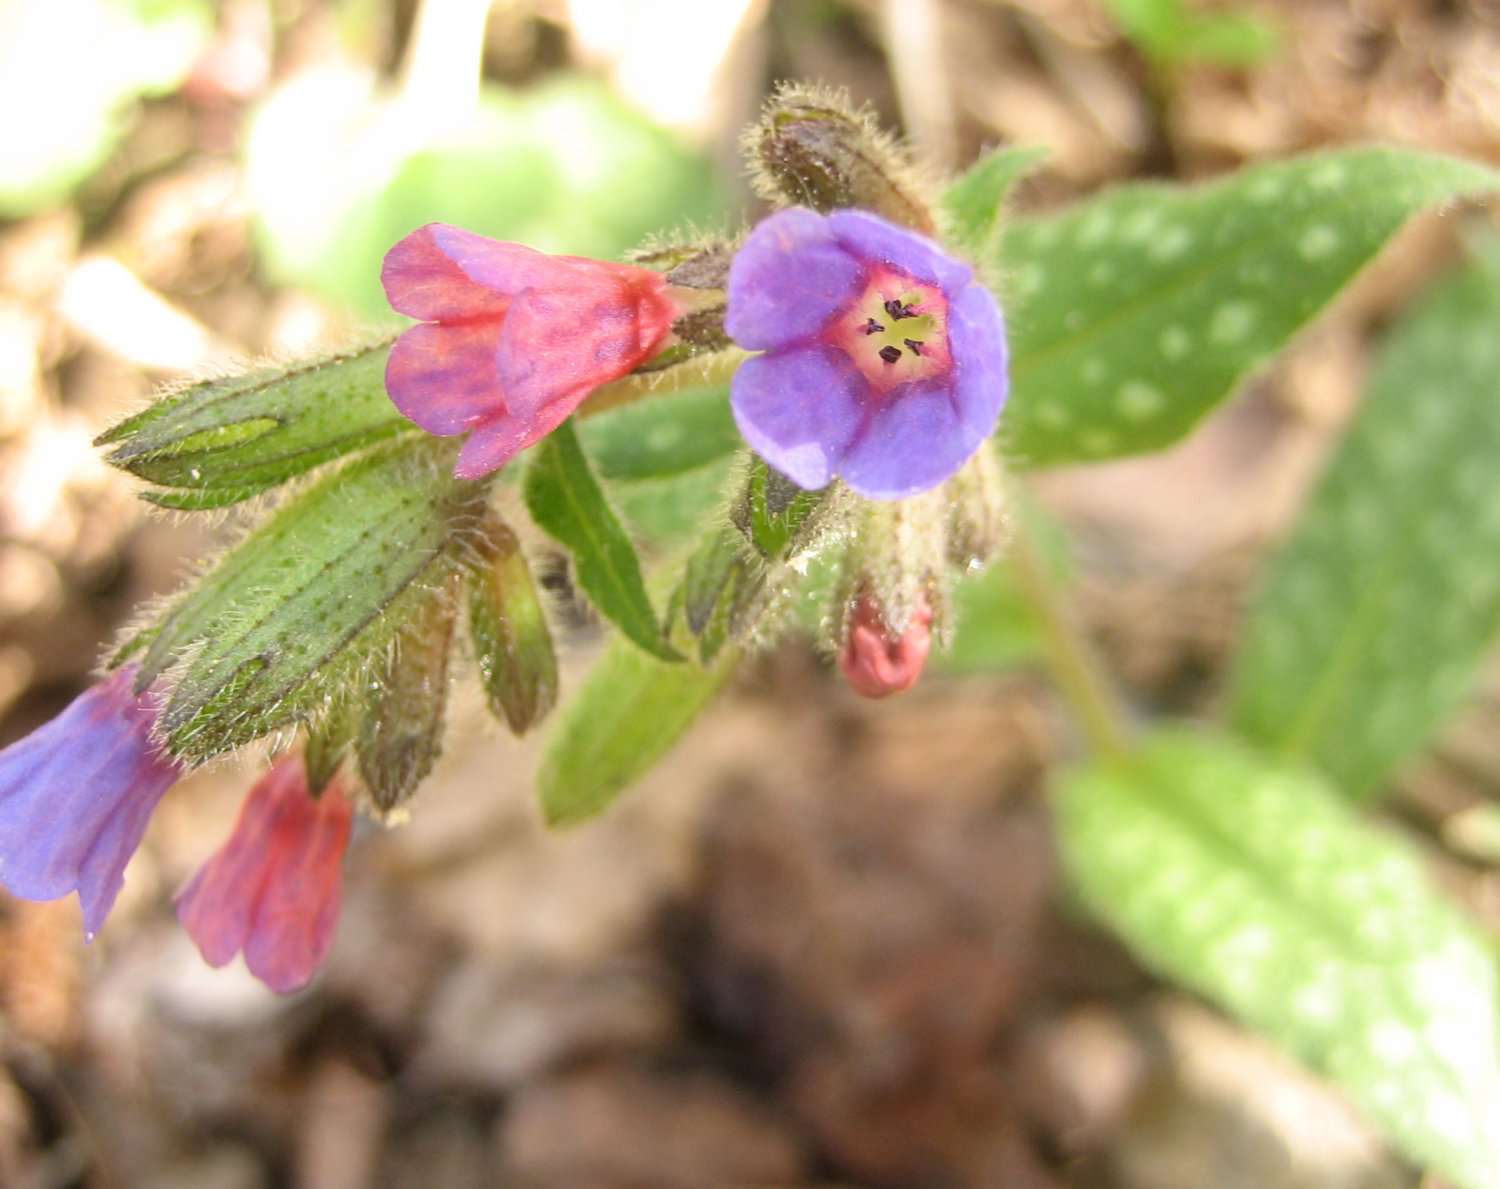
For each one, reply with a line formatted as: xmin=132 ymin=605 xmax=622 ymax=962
xmin=578 ymin=388 xmax=743 ymax=481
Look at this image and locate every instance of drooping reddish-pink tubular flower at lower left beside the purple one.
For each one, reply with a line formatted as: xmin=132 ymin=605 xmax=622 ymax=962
xmin=177 ymin=756 xmax=354 ymax=994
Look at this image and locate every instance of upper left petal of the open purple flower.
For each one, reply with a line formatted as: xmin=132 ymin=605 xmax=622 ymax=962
xmin=725 ymin=207 xmax=866 ymax=351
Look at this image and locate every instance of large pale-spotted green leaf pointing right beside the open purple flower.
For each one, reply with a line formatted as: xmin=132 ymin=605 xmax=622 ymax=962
xmin=999 ymin=148 xmax=1500 ymax=465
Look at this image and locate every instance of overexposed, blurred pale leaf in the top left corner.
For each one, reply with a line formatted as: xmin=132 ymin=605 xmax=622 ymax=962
xmin=0 ymin=0 xmax=213 ymax=216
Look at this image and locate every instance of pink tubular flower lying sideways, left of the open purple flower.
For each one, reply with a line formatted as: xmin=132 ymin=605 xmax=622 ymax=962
xmin=381 ymin=223 xmax=678 ymax=478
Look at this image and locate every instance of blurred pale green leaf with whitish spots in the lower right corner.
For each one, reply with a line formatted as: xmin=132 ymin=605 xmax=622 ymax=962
xmin=1058 ymin=722 xmax=1500 ymax=1189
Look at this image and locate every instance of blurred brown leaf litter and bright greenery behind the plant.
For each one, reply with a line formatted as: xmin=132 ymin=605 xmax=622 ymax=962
xmin=0 ymin=0 xmax=1500 ymax=1189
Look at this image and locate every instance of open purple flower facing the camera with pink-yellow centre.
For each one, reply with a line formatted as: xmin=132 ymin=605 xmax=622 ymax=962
xmin=725 ymin=207 xmax=1008 ymax=499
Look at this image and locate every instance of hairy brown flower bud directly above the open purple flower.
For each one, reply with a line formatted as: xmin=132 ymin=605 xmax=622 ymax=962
xmin=744 ymin=84 xmax=936 ymax=235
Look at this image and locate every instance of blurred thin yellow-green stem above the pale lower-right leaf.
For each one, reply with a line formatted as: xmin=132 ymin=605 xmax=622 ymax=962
xmin=1010 ymin=494 xmax=1130 ymax=756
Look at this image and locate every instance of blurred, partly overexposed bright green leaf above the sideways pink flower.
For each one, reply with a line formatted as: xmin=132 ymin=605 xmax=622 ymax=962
xmin=248 ymin=69 xmax=723 ymax=318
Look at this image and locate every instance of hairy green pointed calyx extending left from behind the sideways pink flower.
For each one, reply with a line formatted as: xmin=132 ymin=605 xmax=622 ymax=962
xmin=95 ymin=342 xmax=413 ymax=510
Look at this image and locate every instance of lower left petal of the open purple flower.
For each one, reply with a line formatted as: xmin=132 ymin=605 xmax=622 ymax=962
xmin=729 ymin=346 xmax=870 ymax=487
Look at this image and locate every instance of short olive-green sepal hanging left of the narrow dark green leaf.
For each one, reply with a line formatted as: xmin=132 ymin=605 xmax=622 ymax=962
xmin=468 ymin=520 xmax=558 ymax=735
